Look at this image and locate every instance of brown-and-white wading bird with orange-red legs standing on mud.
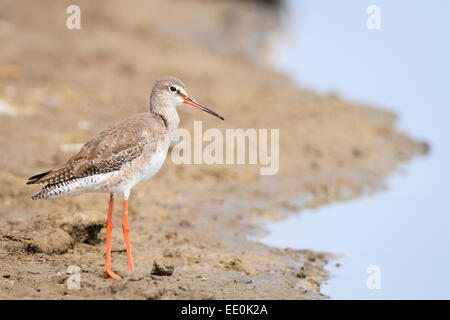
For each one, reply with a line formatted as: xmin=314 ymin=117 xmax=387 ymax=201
xmin=27 ymin=77 xmax=224 ymax=279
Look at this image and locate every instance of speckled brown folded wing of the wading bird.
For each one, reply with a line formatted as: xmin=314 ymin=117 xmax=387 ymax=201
xmin=27 ymin=113 xmax=165 ymax=184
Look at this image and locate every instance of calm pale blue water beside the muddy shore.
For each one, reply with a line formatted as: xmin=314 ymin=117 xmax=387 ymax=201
xmin=263 ymin=0 xmax=450 ymax=299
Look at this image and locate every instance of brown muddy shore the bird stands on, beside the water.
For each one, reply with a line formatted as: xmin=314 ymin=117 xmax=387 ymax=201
xmin=0 ymin=0 xmax=426 ymax=299
